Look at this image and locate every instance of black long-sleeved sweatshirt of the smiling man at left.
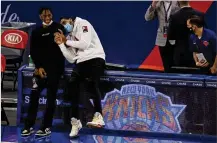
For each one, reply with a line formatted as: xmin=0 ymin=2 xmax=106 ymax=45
xmin=30 ymin=22 xmax=65 ymax=72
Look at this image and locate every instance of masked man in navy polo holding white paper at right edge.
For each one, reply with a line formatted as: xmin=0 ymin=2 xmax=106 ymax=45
xmin=187 ymin=15 xmax=217 ymax=74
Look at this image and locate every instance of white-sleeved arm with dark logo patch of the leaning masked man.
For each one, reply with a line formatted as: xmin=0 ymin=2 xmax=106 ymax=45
xmin=66 ymin=22 xmax=92 ymax=50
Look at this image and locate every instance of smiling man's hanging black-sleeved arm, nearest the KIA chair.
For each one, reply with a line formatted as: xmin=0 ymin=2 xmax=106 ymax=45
xmin=30 ymin=31 xmax=41 ymax=69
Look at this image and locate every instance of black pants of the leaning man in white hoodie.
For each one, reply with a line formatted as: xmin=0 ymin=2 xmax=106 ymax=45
xmin=67 ymin=58 xmax=105 ymax=123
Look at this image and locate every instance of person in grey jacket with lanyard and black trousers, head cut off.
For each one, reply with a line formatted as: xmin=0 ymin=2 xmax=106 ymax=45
xmin=145 ymin=0 xmax=179 ymax=72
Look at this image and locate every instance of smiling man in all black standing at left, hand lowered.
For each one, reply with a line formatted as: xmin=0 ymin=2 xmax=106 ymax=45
xmin=21 ymin=7 xmax=65 ymax=136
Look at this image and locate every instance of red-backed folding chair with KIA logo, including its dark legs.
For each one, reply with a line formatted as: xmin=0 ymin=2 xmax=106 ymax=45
xmin=1 ymin=29 xmax=28 ymax=90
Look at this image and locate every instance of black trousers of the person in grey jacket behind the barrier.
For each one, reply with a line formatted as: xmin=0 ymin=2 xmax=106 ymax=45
xmin=159 ymin=41 xmax=174 ymax=73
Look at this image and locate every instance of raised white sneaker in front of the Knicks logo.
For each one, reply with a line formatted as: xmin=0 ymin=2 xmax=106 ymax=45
xmin=87 ymin=112 xmax=105 ymax=128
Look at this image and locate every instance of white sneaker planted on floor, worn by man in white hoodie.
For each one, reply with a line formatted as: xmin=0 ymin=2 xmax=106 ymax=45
xmin=69 ymin=118 xmax=82 ymax=138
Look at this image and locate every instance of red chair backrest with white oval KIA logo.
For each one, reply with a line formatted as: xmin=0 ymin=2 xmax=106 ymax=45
xmin=1 ymin=29 xmax=28 ymax=49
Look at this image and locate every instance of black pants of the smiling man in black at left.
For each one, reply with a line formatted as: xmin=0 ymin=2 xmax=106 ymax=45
xmin=25 ymin=72 xmax=61 ymax=129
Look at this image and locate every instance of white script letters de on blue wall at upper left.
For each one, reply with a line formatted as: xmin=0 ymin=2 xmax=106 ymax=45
xmin=1 ymin=4 xmax=20 ymax=24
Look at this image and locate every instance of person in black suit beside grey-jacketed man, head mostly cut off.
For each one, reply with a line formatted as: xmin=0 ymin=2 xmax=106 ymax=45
xmin=168 ymin=1 xmax=204 ymax=67
